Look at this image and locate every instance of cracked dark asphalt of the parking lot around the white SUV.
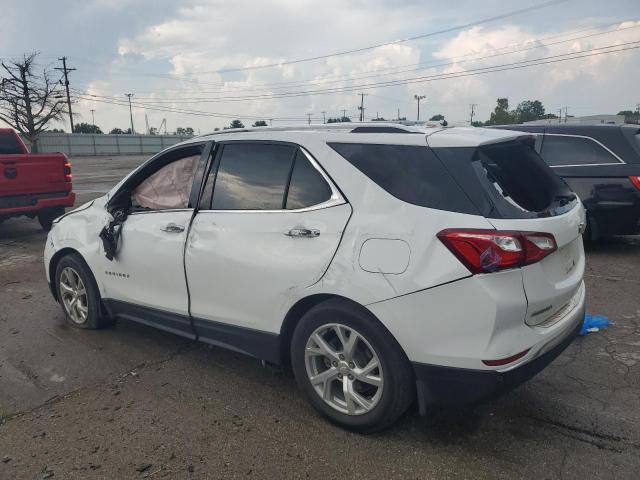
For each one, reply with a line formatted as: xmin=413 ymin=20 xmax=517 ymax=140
xmin=0 ymin=157 xmax=640 ymax=479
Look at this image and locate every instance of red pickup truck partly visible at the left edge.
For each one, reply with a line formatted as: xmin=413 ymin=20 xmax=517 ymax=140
xmin=0 ymin=128 xmax=76 ymax=230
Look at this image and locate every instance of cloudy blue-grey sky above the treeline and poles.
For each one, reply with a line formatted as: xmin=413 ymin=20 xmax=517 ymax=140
xmin=0 ymin=0 xmax=640 ymax=133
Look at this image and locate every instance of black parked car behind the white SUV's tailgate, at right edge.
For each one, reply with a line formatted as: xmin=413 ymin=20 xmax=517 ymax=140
xmin=495 ymin=124 xmax=640 ymax=240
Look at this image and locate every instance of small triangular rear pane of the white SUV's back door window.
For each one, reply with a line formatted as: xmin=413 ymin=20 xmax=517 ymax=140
xmin=286 ymin=150 xmax=331 ymax=210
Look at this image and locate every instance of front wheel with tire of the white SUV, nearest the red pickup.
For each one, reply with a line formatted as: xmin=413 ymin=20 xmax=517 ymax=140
xmin=55 ymin=253 xmax=111 ymax=330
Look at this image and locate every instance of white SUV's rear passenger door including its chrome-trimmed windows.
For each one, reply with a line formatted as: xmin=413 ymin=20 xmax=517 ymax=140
xmin=185 ymin=141 xmax=351 ymax=347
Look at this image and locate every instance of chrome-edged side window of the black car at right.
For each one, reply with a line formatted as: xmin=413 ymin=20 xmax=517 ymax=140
xmin=541 ymin=134 xmax=620 ymax=167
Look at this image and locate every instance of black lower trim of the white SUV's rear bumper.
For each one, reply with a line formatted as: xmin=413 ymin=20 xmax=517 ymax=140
xmin=412 ymin=302 xmax=585 ymax=415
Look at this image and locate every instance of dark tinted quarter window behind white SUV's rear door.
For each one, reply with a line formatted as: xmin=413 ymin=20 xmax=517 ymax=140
xmin=329 ymin=143 xmax=478 ymax=215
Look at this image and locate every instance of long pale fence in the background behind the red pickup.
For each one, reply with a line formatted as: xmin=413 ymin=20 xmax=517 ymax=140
xmin=33 ymin=133 xmax=191 ymax=157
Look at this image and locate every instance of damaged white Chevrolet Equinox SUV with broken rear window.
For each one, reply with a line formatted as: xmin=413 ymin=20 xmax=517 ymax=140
xmin=44 ymin=123 xmax=585 ymax=432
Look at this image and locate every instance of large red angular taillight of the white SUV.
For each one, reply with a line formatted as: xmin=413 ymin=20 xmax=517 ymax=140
xmin=438 ymin=228 xmax=558 ymax=273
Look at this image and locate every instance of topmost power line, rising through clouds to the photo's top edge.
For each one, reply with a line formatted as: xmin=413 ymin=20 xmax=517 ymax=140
xmin=186 ymin=0 xmax=569 ymax=73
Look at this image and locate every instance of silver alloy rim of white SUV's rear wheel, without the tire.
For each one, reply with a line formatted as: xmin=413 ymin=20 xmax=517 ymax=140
xmin=305 ymin=323 xmax=384 ymax=415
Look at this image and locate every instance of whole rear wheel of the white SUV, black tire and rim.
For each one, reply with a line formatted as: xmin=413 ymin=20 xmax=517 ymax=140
xmin=291 ymin=299 xmax=415 ymax=433
